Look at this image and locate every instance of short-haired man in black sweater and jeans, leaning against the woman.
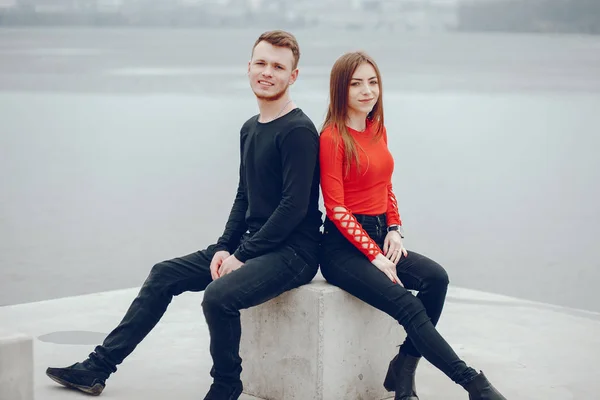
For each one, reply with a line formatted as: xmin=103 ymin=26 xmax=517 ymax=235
xmin=46 ymin=31 xmax=322 ymax=400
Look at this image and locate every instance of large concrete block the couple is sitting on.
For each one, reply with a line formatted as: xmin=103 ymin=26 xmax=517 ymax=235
xmin=240 ymin=276 xmax=406 ymax=400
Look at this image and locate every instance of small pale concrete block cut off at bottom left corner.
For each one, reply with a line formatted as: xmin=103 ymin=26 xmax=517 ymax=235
xmin=0 ymin=335 xmax=33 ymax=400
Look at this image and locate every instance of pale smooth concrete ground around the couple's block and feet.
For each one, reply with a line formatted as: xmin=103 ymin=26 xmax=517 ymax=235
xmin=0 ymin=276 xmax=600 ymax=400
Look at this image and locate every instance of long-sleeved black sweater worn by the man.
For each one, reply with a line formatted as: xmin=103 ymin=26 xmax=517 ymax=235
xmin=216 ymin=108 xmax=322 ymax=265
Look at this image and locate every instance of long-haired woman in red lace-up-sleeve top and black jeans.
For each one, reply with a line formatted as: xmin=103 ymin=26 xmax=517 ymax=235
xmin=320 ymin=52 xmax=506 ymax=400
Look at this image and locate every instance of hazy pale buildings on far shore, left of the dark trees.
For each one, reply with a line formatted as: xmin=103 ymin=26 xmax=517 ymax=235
xmin=0 ymin=0 xmax=458 ymax=31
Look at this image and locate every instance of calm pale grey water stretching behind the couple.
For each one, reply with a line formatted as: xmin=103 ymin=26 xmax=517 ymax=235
xmin=0 ymin=28 xmax=600 ymax=312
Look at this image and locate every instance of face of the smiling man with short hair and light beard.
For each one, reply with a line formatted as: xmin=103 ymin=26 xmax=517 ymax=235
xmin=248 ymin=41 xmax=298 ymax=101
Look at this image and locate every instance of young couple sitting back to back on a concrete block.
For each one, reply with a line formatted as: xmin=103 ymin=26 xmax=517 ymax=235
xmin=46 ymin=31 xmax=505 ymax=400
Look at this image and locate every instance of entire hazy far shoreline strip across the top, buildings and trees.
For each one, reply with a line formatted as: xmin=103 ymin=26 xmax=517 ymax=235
xmin=0 ymin=0 xmax=600 ymax=35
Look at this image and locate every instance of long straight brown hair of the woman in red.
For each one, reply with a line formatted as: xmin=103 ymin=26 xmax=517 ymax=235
xmin=322 ymin=51 xmax=383 ymax=174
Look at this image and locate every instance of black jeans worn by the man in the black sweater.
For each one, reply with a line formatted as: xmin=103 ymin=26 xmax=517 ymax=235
xmin=90 ymin=245 xmax=318 ymax=384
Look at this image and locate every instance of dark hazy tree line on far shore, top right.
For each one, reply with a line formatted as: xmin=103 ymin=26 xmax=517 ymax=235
xmin=458 ymin=0 xmax=600 ymax=34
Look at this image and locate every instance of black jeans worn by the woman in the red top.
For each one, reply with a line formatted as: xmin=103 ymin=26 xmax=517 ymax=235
xmin=320 ymin=214 xmax=477 ymax=385
